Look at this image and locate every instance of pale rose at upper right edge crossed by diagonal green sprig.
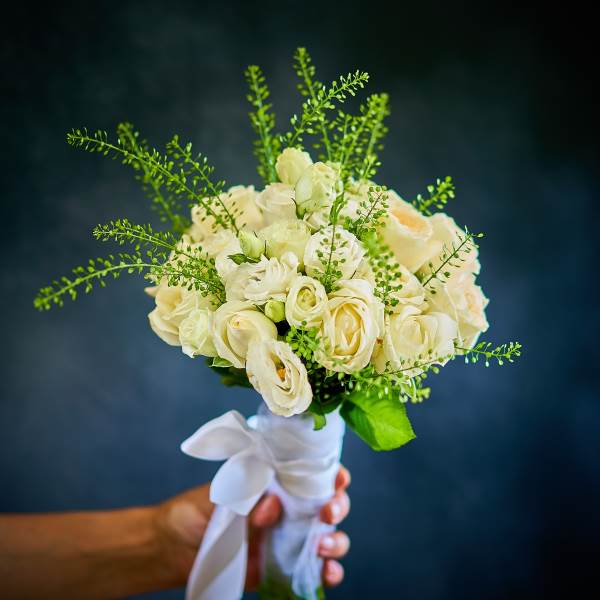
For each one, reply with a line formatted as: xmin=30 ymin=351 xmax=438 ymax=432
xmin=421 ymin=213 xmax=480 ymax=274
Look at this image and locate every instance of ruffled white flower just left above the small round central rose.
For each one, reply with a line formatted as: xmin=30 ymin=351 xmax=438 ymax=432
xmin=225 ymin=252 xmax=298 ymax=304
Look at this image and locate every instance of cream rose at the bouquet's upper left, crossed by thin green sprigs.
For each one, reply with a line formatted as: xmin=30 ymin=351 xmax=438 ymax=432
xmin=189 ymin=185 xmax=263 ymax=240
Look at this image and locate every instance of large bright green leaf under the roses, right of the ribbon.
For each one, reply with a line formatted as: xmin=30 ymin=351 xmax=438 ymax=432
xmin=341 ymin=391 xmax=416 ymax=450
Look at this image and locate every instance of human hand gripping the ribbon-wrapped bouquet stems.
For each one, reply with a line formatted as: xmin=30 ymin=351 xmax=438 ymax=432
xmin=153 ymin=467 xmax=350 ymax=591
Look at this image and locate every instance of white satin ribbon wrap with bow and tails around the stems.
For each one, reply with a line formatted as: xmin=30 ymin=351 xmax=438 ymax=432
xmin=181 ymin=405 xmax=344 ymax=600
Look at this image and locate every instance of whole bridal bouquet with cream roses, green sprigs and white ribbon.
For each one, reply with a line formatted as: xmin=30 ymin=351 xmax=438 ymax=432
xmin=35 ymin=48 xmax=520 ymax=600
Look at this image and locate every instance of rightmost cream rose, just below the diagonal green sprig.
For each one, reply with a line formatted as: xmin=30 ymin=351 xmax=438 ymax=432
xmin=428 ymin=272 xmax=489 ymax=348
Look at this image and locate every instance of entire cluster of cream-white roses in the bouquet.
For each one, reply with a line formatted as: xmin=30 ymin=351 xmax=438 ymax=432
xmin=149 ymin=148 xmax=488 ymax=416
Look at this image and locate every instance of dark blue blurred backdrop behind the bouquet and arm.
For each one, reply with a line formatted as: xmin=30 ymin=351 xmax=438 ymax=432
xmin=0 ymin=0 xmax=600 ymax=600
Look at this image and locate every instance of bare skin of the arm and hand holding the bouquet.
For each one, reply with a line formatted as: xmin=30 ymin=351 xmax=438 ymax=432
xmin=0 ymin=467 xmax=350 ymax=600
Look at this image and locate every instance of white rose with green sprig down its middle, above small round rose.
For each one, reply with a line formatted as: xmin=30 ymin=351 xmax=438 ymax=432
xmin=304 ymin=225 xmax=365 ymax=279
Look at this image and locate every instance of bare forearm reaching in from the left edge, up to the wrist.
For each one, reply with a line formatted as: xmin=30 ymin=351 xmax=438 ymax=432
xmin=0 ymin=508 xmax=176 ymax=600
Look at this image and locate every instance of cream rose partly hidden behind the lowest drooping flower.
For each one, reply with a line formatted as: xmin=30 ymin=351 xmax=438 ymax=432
xmin=212 ymin=301 xmax=277 ymax=369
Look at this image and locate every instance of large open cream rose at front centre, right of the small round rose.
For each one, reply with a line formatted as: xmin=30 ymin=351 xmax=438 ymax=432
xmin=315 ymin=279 xmax=383 ymax=373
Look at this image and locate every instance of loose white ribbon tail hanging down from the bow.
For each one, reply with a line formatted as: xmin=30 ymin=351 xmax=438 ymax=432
xmin=185 ymin=506 xmax=248 ymax=600
